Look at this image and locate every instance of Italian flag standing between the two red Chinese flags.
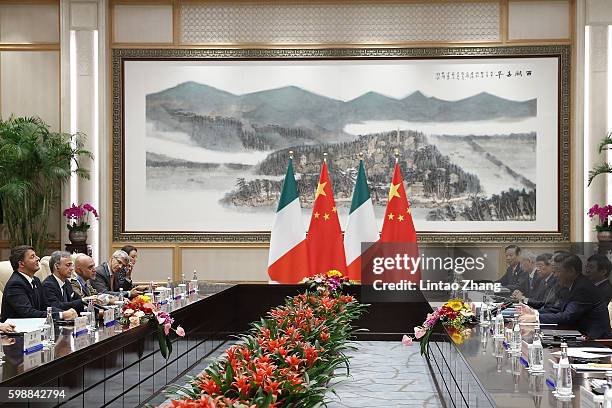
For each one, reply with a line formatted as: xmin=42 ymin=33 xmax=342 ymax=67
xmin=344 ymin=160 xmax=378 ymax=280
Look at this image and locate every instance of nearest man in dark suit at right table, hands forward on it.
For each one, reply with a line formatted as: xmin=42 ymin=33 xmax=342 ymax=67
xmin=520 ymin=255 xmax=610 ymax=339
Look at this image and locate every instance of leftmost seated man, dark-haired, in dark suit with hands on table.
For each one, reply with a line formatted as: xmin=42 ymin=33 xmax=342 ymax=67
xmin=0 ymin=245 xmax=77 ymax=321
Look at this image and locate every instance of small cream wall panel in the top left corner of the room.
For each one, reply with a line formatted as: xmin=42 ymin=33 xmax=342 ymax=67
xmin=0 ymin=4 xmax=59 ymax=43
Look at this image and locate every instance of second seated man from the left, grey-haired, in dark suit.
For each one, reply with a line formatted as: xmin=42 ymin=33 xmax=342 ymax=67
xmin=43 ymin=251 xmax=85 ymax=313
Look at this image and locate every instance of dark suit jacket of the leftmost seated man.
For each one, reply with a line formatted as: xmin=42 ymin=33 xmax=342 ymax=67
xmin=0 ymin=272 xmax=61 ymax=321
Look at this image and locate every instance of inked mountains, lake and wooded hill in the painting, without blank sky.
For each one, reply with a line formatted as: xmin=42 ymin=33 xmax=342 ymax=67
xmin=146 ymin=82 xmax=537 ymax=226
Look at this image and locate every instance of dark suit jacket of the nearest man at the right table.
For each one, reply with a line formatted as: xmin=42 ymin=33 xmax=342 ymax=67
xmin=540 ymin=275 xmax=610 ymax=339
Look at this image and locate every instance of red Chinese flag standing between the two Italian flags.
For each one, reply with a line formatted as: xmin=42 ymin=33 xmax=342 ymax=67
xmin=306 ymin=161 xmax=346 ymax=275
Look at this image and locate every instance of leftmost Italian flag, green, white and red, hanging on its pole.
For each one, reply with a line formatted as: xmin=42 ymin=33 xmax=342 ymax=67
xmin=268 ymin=158 xmax=308 ymax=283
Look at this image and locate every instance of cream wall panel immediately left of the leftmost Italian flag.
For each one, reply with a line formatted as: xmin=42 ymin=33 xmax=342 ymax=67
xmin=181 ymin=248 xmax=268 ymax=282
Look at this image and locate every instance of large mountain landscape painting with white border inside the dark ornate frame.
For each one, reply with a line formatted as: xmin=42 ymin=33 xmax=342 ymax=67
xmin=119 ymin=49 xmax=558 ymax=237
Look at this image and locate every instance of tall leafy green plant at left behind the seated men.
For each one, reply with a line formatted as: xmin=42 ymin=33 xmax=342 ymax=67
xmin=0 ymin=116 xmax=93 ymax=254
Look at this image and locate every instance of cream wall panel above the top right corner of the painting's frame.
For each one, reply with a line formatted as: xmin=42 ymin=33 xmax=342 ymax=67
xmin=508 ymin=0 xmax=571 ymax=40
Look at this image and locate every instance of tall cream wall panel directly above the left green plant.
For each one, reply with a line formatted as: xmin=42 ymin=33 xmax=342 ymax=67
xmin=0 ymin=51 xmax=60 ymax=131
